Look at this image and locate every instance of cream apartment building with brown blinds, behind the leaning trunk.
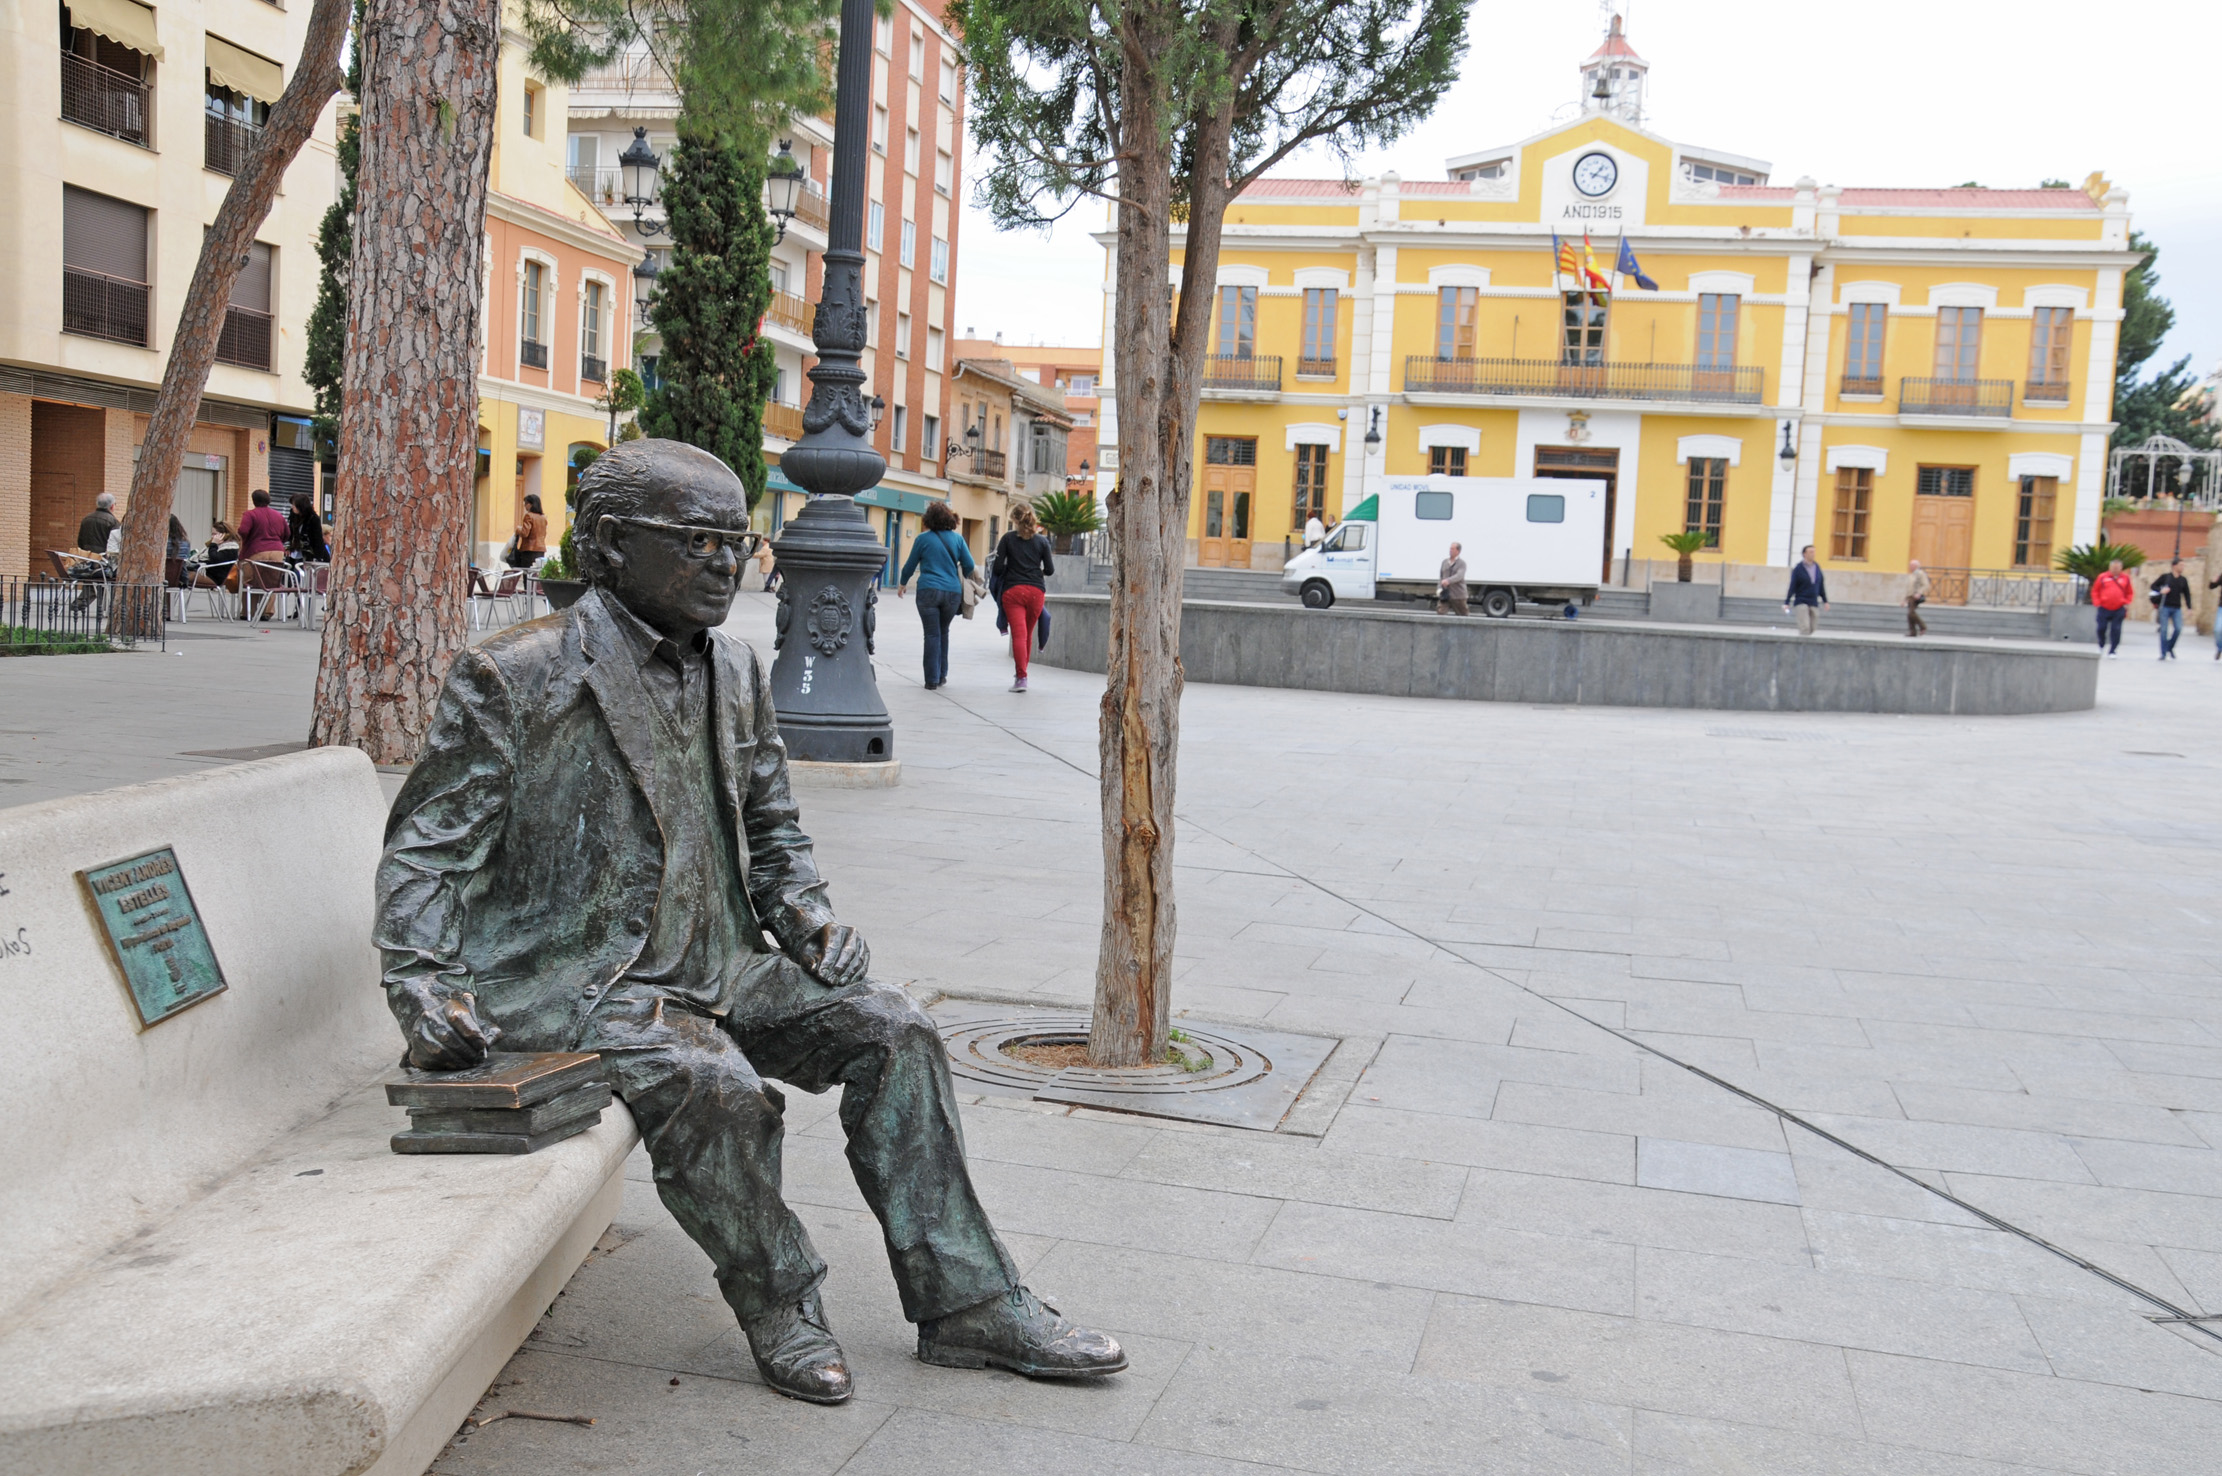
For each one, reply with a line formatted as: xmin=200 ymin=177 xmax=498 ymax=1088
xmin=0 ymin=0 xmax=338 ymax=576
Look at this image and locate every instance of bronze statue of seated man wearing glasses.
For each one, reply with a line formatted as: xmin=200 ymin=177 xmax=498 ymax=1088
xmin=376 ymin=440 xmax=1127 ymax=1403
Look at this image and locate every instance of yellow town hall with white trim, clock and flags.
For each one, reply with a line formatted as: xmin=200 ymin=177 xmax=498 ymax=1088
xmin=1098 ymin=20 xmax=2135 ymax=600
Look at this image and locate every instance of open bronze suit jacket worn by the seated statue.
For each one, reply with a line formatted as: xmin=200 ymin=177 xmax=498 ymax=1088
xmin=376 ymin=591 xmax=833 ymax=1049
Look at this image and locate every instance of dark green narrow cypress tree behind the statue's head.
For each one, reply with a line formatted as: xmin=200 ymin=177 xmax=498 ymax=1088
xmin=640 ymin=133 xmax=778 ymax=507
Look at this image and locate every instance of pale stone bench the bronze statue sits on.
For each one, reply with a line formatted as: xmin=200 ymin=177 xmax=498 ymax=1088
xmin=0 ymin=749 xmax=635 ymax=1476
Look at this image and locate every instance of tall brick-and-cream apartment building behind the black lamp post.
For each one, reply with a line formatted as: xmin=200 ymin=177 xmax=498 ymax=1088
xmin=567 ymin=0 xmax=964 ymax=560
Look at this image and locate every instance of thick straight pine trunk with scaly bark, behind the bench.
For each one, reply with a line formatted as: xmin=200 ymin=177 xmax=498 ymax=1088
xmin=309 ymin=0 xmax=502 ymax=765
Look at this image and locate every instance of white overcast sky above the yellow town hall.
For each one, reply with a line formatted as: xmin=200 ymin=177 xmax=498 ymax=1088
xmin=958 ymin=0 xmax=2222 ymax=386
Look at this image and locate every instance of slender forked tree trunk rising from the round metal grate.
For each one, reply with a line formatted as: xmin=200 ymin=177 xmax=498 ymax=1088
xmin=1089 ymin=7 xmax=1231 ymax=1067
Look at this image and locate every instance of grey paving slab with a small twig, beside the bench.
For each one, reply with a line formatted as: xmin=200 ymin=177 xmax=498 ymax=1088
xmin=431 ymin=1347 xmax=893 ymax=1476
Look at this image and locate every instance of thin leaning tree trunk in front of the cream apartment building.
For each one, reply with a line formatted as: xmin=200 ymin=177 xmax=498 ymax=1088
xmin=118 ymin=0 xmax=351 ymax=638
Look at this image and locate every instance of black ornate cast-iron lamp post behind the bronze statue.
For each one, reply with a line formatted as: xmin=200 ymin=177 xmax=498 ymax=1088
xmin=771 ymin=0 xmax=895 ymax=762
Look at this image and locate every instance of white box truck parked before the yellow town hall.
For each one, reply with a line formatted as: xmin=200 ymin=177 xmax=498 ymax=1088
xmin=1280 ymin=476 xmax=1604 ymax=620
